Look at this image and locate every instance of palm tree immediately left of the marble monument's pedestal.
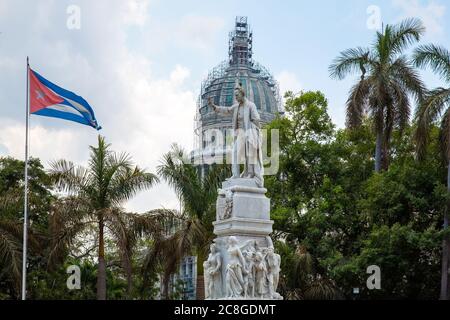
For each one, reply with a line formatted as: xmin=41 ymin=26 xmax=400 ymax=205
xmin=145 ymin=145 xmax=230 ymax=298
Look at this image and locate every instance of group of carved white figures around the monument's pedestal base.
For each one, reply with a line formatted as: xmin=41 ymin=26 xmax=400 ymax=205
xmin=204 ymin=236 xmax=281 ymax=299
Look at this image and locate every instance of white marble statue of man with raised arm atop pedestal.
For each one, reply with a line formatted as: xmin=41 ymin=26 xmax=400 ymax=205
xmin=208 ymin=86 xmax=264 ymax=188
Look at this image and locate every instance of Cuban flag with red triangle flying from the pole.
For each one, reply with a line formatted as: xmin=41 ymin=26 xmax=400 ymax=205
xmin=28 ymin=68 xmax=101 ymax=130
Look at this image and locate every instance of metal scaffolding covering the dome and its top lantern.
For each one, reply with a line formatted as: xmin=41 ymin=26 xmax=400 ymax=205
xmin=194 ymin=16 xmax=283 ymax=158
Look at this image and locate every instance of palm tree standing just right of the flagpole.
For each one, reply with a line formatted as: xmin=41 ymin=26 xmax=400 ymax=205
xmin=49 ymin=136 xmax=158 ymax=300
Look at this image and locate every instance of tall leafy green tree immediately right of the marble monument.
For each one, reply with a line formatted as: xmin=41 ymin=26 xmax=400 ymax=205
xmin=265 ymin=92 xmax=341 ymax=299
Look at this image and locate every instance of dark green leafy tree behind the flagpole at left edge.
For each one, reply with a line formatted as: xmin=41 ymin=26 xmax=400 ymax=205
xmin=0 ymin=157 xmax=54 ymax=298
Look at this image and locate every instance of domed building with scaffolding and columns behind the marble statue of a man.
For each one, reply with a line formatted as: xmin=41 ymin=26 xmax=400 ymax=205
xmin=192 ymin=17 xmax=282 ymax=169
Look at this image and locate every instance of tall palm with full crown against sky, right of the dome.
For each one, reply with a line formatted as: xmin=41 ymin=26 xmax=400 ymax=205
xmin=329 ymin=19 xmax=425 ymax=172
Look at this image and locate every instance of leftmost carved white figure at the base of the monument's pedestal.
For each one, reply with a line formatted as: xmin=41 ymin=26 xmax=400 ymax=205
xmin=203 ymin=243 xmax=222 ymax=299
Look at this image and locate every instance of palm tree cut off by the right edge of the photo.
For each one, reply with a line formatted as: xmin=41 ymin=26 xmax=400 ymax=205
xmin=414 ymin=44 xmax=450 ymax=300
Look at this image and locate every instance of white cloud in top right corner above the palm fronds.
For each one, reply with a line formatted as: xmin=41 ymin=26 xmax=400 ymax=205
xmin=392 ymin=0 xmax=446 ymax=36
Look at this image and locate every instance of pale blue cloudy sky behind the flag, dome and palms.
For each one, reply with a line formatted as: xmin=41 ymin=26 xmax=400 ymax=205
xmin=0 ymin=0 xmax=450 ymax=212
